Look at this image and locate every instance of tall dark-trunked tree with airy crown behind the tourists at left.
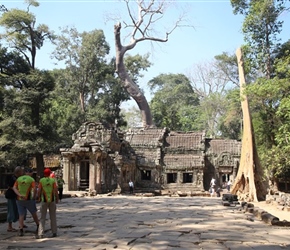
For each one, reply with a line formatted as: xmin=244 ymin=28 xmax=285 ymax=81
xmin=0 ymin=0 xmax=53 ymax=175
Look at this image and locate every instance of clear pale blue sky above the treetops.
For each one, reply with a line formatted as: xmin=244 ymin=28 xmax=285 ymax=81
xmin=1 ymin=0 xmax=290 ymax=108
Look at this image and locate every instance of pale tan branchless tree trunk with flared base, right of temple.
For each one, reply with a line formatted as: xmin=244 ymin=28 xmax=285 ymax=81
xmin=231 ymin=48 xmax=266 ymax=201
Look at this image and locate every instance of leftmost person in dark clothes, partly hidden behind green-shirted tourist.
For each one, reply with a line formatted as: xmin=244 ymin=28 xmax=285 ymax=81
xmin=5 ymin=166 xmax=23 ymax=232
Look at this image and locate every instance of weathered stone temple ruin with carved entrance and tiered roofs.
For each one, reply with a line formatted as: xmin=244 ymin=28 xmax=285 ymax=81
xmin=61 ymin=122 xmax=241 ymax=195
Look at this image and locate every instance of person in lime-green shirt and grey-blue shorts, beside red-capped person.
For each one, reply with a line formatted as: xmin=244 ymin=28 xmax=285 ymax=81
xmin=13 ymin=167 xmax=39 ymax=236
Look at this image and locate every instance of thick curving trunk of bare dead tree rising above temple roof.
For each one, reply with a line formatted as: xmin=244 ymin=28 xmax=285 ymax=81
xmin=114 ymin=23 xmax=153 ymax=127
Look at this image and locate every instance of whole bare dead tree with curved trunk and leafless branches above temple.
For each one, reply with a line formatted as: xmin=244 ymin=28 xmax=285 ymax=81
xmin=114 ymin=0 xmax=182 ymax=128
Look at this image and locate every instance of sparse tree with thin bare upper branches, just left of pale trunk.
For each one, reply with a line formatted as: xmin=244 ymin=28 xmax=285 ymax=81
xmin=189 ymin=52 xmax=240 ymax=138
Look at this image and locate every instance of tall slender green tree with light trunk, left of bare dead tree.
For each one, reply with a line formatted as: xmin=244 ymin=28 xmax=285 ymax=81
xmin=54 ymin=27 xmax=110 ymax=113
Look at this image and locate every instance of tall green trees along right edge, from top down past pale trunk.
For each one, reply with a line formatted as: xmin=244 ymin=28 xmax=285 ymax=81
xmin=231 ymin=0 xmax=290 ymax=178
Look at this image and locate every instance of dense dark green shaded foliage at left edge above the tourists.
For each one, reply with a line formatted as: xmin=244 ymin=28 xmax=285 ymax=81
xmin=0 ymin=71 xmax=54 ymax=166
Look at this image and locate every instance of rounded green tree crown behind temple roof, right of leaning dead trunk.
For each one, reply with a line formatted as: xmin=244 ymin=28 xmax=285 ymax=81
xmin=149 ymin=74 xmax=199 ymax=131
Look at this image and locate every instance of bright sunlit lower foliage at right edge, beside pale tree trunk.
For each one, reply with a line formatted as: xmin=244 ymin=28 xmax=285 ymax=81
xmin=247 ymin=48 xmax=290 ymax=178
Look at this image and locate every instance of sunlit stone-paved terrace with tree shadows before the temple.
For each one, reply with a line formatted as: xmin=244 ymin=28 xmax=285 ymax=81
xmin=0 ymin=195 xmax=290 ymax=250
